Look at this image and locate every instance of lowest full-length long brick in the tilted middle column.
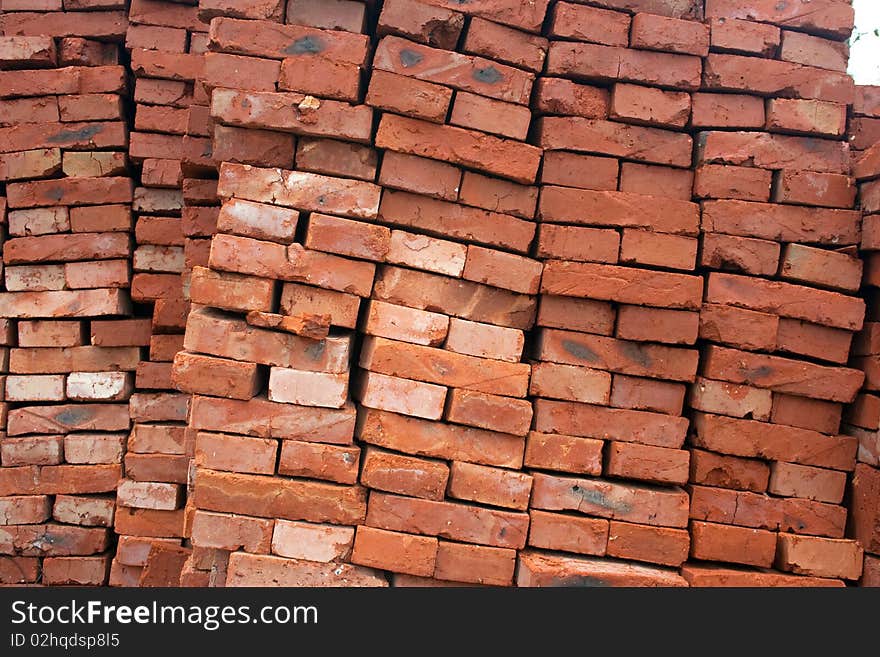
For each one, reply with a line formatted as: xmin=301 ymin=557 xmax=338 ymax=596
xmin=367 ymin=492 xmax=529 ymax=549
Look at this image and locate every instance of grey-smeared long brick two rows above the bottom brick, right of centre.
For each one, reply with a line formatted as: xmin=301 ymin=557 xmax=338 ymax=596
xmin=531 ymin=473 xmax=688 ymax=527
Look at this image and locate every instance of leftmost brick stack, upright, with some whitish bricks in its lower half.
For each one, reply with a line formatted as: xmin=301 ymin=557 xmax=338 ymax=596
xmin=0 ymin=9 xmax=134 ymax=585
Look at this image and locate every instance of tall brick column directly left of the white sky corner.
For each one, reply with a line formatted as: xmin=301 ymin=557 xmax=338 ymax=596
xmin=683 ymin=0 xmax=865 ymax=586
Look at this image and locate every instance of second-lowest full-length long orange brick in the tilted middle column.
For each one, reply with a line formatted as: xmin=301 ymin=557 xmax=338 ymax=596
xmin=357 ymin=409 xmax=524 ymax=468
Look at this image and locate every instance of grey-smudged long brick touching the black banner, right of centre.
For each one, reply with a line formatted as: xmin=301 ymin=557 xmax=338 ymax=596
xmin=516 ymin=552 xmax=687 ymax=587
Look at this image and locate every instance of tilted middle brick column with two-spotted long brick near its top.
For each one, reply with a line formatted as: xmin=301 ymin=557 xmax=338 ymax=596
xmin=354 ymin=0 xmax=548 ymax=586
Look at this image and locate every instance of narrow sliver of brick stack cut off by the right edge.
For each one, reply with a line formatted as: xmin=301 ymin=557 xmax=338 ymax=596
xmin=844 ymin=98 xmax=880 ymax=586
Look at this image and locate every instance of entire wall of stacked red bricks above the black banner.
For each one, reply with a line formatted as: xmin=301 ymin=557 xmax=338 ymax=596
xmin=0 ymin=0 xmax=880 ymax=586
